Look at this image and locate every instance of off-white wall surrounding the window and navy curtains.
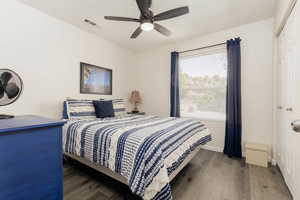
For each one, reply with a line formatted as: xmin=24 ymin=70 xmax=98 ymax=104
xmin=136 ymin=19 xmax=273 ymax=153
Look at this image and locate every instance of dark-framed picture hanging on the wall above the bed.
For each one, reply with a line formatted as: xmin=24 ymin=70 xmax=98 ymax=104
xmin=80 ymin=63 xmax=112 ymax=95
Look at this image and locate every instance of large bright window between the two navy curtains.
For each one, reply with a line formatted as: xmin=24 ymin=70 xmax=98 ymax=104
xmin=179 ymin=48 xmax=227 ymax=120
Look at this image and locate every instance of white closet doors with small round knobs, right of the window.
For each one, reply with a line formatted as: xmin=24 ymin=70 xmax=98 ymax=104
xmin=277 ymin=7 xmax=293 ymax=188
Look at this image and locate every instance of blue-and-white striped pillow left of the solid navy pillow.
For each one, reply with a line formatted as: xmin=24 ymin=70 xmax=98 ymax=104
xmin=64 ymin=99 xmax=96 ymax=119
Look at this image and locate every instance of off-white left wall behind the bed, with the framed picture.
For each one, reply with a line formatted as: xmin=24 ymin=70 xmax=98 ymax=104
xmin=0 ymin=0 xmax=133 ymax=118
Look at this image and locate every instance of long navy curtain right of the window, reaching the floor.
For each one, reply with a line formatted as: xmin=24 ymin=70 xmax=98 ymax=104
xmin=224 ymin=38 xmax=242 ymax=158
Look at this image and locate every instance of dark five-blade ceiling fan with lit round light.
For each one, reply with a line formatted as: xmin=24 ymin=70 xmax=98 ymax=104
xmin=104 ymin=0 xmax=189 ymax=39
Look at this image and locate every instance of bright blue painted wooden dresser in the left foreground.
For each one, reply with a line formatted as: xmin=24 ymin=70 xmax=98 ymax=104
xmin=0 ymin=116 xmax=64 ymax=200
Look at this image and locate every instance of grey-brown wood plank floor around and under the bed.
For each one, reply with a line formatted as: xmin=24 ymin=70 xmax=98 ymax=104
xmin=64 ymin=150 xmax=292 ymax=200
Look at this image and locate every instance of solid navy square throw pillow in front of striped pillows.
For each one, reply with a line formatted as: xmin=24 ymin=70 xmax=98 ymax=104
xmin=93 ymin=101 xmax=115 ymax=118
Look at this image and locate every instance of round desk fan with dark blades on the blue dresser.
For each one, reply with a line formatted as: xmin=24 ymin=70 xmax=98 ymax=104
xmin=0 ymin=69 xmax=23 ymax=119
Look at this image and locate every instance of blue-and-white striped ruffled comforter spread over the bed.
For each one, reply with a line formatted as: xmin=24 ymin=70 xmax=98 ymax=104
xmin=63 ymin=115 xmax=211 ymax=200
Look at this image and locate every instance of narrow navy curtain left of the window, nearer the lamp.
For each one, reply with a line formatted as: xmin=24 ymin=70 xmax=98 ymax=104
xmin=171 ymin=52 xmax=180 ymax=117
